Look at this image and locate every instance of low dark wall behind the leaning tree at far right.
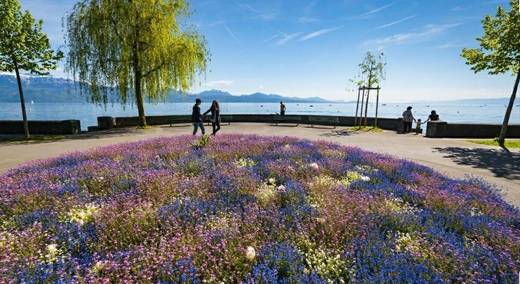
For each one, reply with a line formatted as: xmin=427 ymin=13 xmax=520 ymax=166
xmin=426 ymin=121 xmax=520 ymax=138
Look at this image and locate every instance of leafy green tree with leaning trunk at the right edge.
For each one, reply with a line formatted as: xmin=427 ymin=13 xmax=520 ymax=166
xmin=462 ymin=0 xmax=520 ymax=147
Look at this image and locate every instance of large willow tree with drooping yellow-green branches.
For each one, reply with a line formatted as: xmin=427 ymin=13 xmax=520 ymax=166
xmin=67 ymin=0 xmax=208 ymax=126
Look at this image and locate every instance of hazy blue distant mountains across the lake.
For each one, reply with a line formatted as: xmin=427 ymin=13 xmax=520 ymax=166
xmin=0 ymin=75 xmax=331 ymax=103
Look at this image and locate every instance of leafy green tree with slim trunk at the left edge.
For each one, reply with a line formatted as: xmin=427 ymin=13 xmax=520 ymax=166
xmin=0 ymin=0 xmax=63 ymax=138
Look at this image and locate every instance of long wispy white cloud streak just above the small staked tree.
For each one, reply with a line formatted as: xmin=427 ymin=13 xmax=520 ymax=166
xmin=364 ymin=24 xmax=460 ymax=46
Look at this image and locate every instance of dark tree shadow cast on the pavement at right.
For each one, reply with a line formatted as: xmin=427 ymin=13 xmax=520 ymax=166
xmin=435 ymin=147 xmax=520 ymax=180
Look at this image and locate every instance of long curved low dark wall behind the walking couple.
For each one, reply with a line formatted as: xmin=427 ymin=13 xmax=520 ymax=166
xmin=97 ymin=114 xmax=402 ymax=131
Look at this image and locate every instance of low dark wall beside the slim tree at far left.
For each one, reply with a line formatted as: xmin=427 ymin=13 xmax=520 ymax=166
xmin=0 ymin=120 xmax=81 ymax=135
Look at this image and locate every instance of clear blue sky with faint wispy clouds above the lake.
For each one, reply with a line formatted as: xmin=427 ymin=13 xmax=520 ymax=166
xmin=21 ymin=0 xmax=514 ymax=101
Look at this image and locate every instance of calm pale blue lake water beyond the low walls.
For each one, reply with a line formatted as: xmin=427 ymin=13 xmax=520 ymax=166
xmin=0 ymin=102 xmax=520 ymax=129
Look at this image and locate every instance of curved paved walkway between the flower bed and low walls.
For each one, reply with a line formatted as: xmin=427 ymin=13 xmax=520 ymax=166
xmin=0 ymin=123 xmax=520 ymax=207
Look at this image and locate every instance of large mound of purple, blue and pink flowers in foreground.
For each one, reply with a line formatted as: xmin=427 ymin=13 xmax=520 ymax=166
xmin=0 ymin=135 xmax=520 ymax=283
